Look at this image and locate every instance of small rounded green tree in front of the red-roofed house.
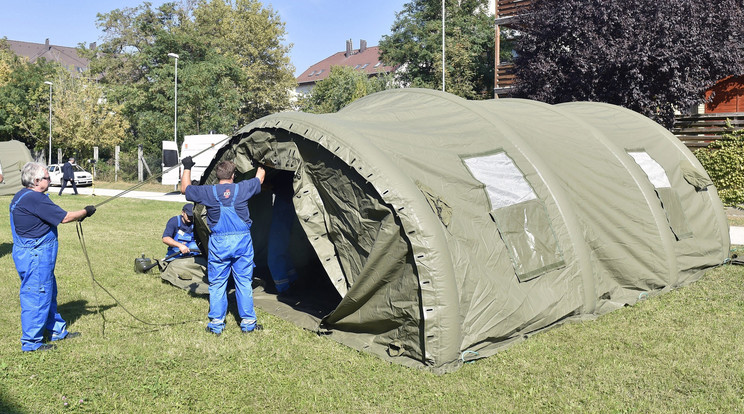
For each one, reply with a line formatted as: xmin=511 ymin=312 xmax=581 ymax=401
xmin=299 ymin=66 xmax=394 ymax=114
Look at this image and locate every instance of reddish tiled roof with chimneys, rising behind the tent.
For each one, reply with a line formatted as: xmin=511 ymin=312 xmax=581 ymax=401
xmin=297 ymin=46 xmax=395 ymax=85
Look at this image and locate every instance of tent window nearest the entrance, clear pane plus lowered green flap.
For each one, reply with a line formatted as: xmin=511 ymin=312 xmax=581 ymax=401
xmin=464 ymin=152 xmax=565 ymax=282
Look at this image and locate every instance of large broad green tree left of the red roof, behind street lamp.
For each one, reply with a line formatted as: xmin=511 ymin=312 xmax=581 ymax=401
xmin=81 ymin=0 xmax=294 ymax=151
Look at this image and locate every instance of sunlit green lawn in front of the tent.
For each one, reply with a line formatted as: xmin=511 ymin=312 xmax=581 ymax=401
xmin=0 ymin=196 xmax=744 ymax=413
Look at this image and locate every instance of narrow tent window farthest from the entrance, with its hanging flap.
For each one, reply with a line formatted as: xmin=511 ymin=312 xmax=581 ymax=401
xmin=628 ymin=151 xmax=692 ymax=240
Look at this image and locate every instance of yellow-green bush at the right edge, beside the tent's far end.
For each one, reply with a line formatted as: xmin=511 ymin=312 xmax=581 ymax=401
xmin=695 ymin=130 xmax=744 ymax=206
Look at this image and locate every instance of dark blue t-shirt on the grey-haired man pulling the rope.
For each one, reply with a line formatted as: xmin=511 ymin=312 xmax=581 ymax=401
xmin=10 ymin=188 xmax=67 ymax=239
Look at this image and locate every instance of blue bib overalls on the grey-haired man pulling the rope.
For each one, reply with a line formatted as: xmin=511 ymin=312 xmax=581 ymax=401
xmin=10 ymin=192 xmax=67 ymax=351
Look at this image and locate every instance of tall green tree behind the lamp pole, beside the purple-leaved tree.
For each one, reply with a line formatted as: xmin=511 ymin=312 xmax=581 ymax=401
xmin=380 ymin=0 xmax=494 ymax=99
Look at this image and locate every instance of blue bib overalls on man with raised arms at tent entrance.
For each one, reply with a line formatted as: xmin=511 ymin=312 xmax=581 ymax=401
xmin=207 ymin=184 xmax=256 ymax=333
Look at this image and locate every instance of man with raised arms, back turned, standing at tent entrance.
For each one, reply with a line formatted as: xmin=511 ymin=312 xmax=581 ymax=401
xmin=181 ymin=157 xmax=266 ymax=335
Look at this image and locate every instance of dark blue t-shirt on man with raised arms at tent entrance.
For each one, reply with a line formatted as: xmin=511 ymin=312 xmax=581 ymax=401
xmin=185 ymin=177 xmax=261 ymax=228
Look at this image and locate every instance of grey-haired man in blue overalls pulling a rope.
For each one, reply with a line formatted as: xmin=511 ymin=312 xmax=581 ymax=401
xmin=10 ymin=162 xmax=96 ymax=352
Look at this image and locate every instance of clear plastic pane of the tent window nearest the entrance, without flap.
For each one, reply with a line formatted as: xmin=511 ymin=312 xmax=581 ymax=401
xmin=464 ymin=152 xmax=537 ymax=210
